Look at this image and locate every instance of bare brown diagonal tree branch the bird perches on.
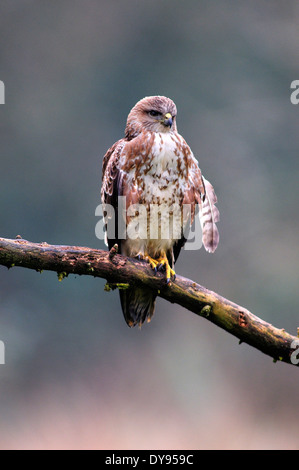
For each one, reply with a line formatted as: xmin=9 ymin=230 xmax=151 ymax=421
xmin=0 ymin=237 xmax=299 ymax=366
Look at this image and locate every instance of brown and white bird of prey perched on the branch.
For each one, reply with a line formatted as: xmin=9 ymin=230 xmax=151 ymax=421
xmin=101 ymin=96 xmax=219 ymax=327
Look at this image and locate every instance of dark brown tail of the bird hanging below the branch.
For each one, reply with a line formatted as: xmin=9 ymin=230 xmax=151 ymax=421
xmin=119 ymin=288 xmax=156 ymax=327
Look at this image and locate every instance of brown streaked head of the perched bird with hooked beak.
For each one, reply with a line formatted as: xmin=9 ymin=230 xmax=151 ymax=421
xmin=125 ymin=96 xmax=177 ymax=138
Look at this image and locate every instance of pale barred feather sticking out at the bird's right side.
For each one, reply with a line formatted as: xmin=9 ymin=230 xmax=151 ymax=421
xmin=199 ymin=178 xmax=219 ymax=253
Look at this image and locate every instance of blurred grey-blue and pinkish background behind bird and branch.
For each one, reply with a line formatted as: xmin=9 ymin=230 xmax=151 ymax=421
xmin=0 ymin=0 xmax=299 ymax=450
